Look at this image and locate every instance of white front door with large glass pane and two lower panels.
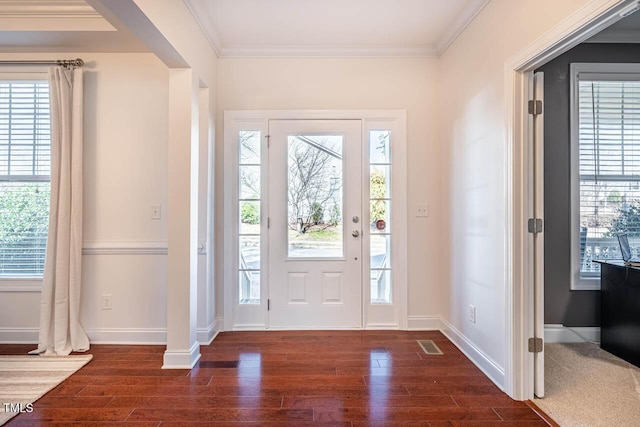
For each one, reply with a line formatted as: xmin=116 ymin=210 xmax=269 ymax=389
xmin=268 ymin=120 xmax=368 ymax=329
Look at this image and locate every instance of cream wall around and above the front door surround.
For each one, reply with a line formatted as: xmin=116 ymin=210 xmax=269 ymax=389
xmin=216 ymin=58 xmax=448 ymax=326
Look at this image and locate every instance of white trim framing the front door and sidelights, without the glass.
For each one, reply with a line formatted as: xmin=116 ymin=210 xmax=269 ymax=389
xmin=222 ymin=110 xmax=408 ymax=330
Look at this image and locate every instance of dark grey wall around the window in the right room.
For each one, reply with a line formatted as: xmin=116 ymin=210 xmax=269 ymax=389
xmin=536 ymin=43 xmax=640 ymax=326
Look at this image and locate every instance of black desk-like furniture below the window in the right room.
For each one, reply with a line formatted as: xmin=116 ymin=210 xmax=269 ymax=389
xmin=599 ymin=260 xmax=640 ymax=367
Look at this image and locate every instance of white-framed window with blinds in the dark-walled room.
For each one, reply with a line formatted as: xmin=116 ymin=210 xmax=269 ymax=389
xmin=571 ymin=64 xmax=640 ymax=289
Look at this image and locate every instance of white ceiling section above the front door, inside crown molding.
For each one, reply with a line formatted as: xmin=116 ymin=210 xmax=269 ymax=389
xmin=185 ymin=0 xmax=489 ymax=57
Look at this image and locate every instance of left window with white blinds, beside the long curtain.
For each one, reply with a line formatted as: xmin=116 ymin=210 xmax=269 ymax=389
xmin=0 ymin=76 xmax=51 ymax=278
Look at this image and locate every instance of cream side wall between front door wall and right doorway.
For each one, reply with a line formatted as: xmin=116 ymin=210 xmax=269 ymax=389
xmin=440 ymin=0 xmax=587 ymax=383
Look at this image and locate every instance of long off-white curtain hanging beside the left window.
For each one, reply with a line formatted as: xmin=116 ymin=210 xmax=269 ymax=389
xmin=32 ymin=67 xmax=89 ymax=355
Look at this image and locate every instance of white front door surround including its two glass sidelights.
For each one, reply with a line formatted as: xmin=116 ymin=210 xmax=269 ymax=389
xmin=221 ymin=110 xmax=408 ymax=330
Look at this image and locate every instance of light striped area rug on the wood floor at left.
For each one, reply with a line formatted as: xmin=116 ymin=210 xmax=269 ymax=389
xmin=0 ymin=354 xmax=93 ymax=426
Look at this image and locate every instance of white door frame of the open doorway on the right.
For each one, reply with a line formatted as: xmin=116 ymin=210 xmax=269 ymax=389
xmin=504 ymin=0 xmax=640 ymax=400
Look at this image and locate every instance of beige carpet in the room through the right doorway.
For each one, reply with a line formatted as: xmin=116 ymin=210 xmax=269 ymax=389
xmin=534 ymin=343 xmax=640 ymax=427
